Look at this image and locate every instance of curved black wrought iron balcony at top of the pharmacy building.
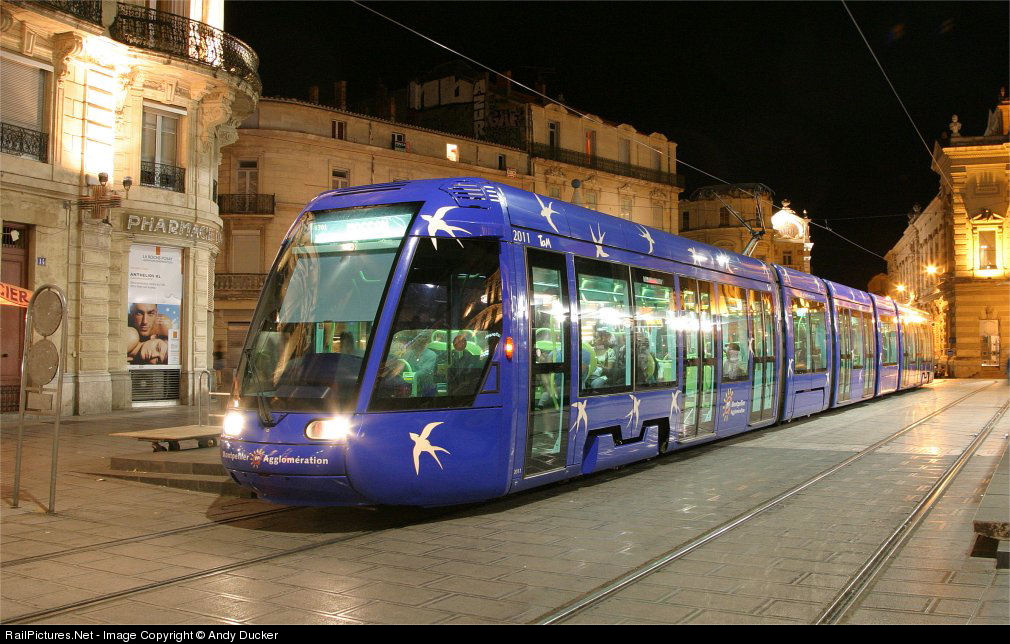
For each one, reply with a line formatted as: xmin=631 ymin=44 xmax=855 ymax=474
xmin=109 ymin=2 xmax=263 ymax=93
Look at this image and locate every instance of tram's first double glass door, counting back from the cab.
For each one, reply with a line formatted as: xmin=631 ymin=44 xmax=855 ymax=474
xmin=678 ymin=278 xmax=715 ymax=440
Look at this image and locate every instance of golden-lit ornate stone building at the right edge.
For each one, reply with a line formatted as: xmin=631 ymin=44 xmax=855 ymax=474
xmin=886 ymin=94 xmax=1010 ymax=378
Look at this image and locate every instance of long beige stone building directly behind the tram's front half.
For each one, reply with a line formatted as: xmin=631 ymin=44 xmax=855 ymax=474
xmin=214 ymin=95 xmax=681 ymax=381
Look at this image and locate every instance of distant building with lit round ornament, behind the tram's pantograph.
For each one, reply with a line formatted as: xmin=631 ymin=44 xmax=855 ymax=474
xmin=677 ymin=184 xmax=813 ymax=273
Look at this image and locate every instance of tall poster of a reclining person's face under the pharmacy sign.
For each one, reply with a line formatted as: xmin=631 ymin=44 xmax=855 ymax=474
xmin=125 ymin=244 xmax=183 ymax=366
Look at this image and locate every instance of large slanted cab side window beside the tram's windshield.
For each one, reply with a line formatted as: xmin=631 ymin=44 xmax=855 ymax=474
xmin=370 ymin=239 xmax=502 ymax=410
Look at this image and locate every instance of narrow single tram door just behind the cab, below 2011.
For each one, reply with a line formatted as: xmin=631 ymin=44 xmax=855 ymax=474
xmin=523 ymin=249 xmax=572 ymax=477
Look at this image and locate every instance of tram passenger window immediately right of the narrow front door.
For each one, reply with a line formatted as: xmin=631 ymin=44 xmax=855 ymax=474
xmin=575 ymin=257 xmax=633 ymax=395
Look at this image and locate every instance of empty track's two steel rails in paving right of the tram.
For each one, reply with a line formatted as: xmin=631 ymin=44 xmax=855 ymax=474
xmin=533 ymin=383 xmax=997 ymax=625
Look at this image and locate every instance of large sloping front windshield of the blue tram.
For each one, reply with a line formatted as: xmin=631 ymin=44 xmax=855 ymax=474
xmin=238 ymin=203 xmax=421 ymax=412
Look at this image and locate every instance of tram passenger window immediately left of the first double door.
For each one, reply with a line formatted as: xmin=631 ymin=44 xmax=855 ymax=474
xmin=633 ymin=269 xmax=677 ymax=388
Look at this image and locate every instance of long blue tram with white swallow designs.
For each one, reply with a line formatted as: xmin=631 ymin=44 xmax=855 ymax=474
xmin=220 ymin=179 xmax=933 ymax=506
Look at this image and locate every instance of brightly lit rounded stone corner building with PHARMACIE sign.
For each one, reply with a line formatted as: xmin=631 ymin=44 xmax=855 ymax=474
xmin=0 ymin=0 xmax=261 ymax=414
